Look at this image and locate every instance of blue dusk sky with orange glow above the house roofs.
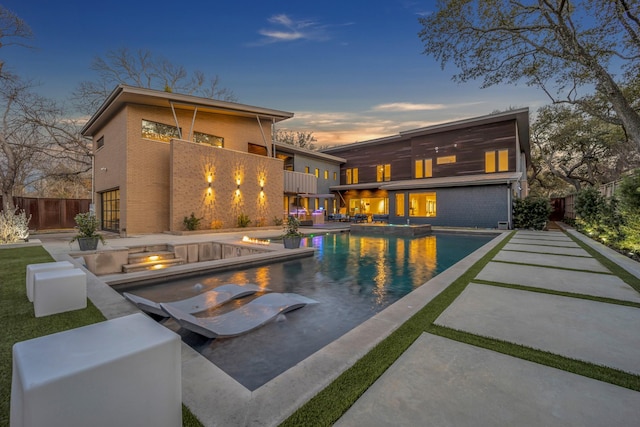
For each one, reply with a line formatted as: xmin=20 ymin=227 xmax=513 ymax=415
xmin=0 ymin=0 xmax=549 ymax=145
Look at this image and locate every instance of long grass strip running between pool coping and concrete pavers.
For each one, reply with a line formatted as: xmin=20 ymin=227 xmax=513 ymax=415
xmin=281 ymin=233 xmax=513 ymax=426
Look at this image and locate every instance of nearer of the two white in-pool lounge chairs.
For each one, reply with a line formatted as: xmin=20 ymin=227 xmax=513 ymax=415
xmin=160 ymin=293 xmax=317 ymax=338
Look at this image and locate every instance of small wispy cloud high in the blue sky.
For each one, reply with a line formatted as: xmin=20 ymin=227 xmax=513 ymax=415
xmin=256 ymin=14 xmax=329 ymax=45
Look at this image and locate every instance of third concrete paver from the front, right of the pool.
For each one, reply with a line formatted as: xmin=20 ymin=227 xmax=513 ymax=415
xmin=476 ymin=262 xmax=640 ymax=303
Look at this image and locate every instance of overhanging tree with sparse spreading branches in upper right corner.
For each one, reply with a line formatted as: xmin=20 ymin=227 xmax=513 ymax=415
xmin=419 ymin=0 xmax=640 ymax=148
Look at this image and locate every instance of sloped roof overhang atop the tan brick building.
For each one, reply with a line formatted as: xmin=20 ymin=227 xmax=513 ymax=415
xmin=80 ymin=85 xmax=293 ymax=136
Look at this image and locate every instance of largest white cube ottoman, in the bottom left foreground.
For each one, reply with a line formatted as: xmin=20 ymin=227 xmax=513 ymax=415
xmin=10 ymin=313 xmax=182 ymax=427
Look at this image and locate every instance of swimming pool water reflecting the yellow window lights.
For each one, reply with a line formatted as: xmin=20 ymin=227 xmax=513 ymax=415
xmin=130 ymin=233 xmax=495 ymax=391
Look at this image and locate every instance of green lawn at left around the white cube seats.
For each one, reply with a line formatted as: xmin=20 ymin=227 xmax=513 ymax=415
xmin=0 ymin=246 xmax=202 ymax=427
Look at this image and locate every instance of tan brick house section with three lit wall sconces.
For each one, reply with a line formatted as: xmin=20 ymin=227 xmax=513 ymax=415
xmin=82 ymin=85 xmax=344 ymax=236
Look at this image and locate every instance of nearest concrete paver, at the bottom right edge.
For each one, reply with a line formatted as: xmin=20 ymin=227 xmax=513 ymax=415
xmin=335 ymin=334 xmax=640 ymax=427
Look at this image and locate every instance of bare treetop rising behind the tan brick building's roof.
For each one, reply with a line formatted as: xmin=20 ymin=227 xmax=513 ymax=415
xmin=72 ymin=48 xmax=236 ymax=114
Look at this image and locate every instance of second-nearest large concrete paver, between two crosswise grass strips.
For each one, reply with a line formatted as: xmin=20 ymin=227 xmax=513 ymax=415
xmin=435 ymin=283 xmax=640 ymax=374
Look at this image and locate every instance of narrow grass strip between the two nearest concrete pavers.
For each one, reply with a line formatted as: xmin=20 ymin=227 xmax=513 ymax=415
xmin=427 ymin=325 xmax=640 ymax=391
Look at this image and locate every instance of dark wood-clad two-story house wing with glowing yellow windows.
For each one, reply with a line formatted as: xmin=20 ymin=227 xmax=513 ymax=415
xmin=323 ymin=108 xmax=530 ymax=228
